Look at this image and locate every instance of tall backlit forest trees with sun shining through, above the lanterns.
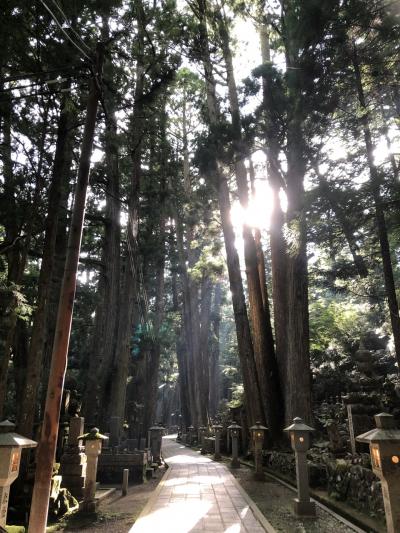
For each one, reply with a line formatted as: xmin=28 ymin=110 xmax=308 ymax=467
xmin=0 ymin=0 xmax=400 ymax=478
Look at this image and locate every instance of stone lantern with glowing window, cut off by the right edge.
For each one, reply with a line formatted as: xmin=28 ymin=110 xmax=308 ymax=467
xmin=356 ymin=413 xmax=400 ymax=533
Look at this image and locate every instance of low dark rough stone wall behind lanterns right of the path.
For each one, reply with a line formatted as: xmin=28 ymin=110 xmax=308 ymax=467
xmin=264 ymin=451 xmax=384 ymax=517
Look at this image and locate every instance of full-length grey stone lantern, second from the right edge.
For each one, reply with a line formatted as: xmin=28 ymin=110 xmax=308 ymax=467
xmin=284 ymin=417 xmax=315 ymax=516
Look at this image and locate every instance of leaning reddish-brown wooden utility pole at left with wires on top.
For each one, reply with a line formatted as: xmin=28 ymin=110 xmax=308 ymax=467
xmin=28 ymin=44 xmax=103 ymax=533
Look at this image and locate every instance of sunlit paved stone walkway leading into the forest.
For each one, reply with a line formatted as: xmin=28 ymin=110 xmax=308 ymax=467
xmin=130 ymin=436 xmax=273 ymax=533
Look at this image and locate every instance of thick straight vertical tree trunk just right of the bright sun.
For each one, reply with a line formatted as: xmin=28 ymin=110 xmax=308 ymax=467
xmin=283 ymin=13 xmax=312 ymax=423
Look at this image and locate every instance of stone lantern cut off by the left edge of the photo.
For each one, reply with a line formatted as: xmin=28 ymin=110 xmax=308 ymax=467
xmin=0 ymin=420 xmax=37 ymax=528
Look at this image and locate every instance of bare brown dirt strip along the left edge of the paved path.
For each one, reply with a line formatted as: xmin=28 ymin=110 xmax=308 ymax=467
xmin=47 ymin=468 xmax=165 ymax=533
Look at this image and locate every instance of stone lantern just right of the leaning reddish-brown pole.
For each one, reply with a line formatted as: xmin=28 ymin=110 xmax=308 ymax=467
xmin=78 ymin=428 xmax=108 ymax=512
